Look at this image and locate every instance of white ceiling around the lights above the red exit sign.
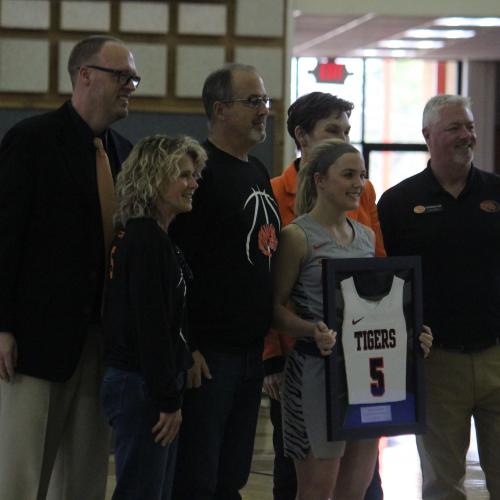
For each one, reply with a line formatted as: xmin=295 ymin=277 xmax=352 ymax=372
xmin=292 ymin=12 xmax=500 ymax=61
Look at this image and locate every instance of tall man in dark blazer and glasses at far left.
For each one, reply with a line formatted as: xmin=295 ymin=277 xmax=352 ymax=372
xmin=0 ymin=36 xmax=140 ymax=500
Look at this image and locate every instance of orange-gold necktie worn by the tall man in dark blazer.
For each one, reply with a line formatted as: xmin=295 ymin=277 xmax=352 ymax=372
xmin=94 ymin=137 xmax=116 ymax=267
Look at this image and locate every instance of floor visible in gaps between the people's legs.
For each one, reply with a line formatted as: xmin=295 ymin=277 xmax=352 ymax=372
xmin=106 ymin=400 xmax=489 ymax=500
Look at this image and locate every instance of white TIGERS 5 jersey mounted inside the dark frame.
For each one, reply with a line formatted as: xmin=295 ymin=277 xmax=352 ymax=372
xmin=340 ymin=276 xmax=408 ymax=404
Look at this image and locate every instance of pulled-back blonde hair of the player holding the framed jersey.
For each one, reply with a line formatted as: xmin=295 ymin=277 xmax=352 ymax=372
xmin=295 ymin=139 xmax=360 ymax=215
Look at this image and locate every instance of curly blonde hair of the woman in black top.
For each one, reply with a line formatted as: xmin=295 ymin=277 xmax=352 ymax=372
xmin=113 ymin=134 xmax=207 ymax=229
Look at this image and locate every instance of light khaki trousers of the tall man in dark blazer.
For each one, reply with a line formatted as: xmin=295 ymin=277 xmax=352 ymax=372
xmin=0 ymin=329 xmax=110 ymax=500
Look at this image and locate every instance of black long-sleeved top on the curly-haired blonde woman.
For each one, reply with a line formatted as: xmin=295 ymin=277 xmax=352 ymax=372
xmin=104 ymin=218 xmax=191 ymax=412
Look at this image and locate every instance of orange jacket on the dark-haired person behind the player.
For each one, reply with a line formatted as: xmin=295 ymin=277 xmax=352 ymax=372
xmin=264 ymin=162 xmax=386 ymax=373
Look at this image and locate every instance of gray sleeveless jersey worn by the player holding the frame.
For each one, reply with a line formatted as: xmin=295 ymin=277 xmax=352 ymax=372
xmin=290 ymin=214 xmax=375 ymax=328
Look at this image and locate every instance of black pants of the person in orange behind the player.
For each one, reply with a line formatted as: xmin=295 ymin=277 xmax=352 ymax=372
xmin=270 ymin=399 xmax=384 ymax=500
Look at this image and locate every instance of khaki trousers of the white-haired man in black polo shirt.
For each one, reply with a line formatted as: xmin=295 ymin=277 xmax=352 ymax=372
xmin=417 ymin=345 xmax=500 ymax=500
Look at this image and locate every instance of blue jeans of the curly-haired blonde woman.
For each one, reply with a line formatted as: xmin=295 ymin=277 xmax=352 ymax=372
xmin=101 ymin=368 xmax=185 ymax=500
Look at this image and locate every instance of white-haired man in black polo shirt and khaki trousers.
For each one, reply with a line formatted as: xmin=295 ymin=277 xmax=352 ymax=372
xmin=378 ymin=95 xmax=500 ymax=500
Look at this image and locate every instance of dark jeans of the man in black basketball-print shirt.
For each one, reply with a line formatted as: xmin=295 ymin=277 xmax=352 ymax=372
xmin=174 ymin=348 xmax=263 ymax=500
